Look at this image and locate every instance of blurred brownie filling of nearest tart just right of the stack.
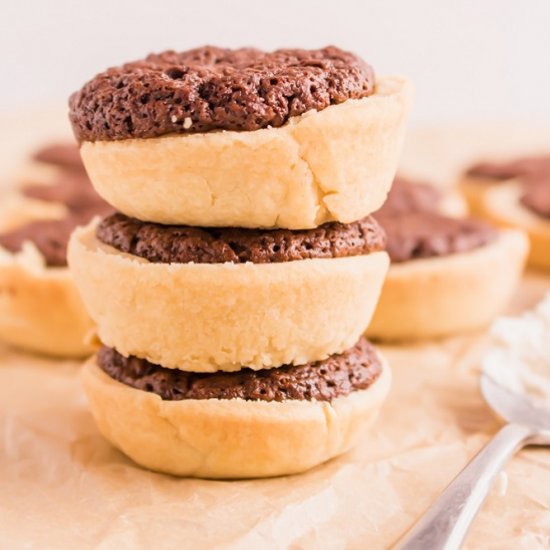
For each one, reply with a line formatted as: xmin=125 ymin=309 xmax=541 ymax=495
xmin=379 ymin=212 xmax=497 ymax=262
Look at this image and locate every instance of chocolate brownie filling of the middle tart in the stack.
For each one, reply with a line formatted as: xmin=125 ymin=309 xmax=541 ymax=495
xmin=96 ymin=213 xmax=386 ymax=264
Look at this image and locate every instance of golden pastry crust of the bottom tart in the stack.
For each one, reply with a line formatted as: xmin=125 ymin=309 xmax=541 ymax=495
xmin=82 ymin=358 xmax=391 ymax=478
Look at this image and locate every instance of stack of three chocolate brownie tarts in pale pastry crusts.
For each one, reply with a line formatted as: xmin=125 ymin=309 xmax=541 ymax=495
xmin=69 ymin=47 xmax=411 ymax=478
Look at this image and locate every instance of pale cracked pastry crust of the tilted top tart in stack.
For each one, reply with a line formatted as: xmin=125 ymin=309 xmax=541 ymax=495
xmin=81 ymin=77 xmax=412 ymax=229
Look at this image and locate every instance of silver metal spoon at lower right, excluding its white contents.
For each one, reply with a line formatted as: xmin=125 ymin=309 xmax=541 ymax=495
xmin=396 ymin=374 xmax=550 ymax=550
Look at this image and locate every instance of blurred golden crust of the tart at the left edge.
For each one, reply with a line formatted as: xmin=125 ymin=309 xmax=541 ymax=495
xmin=0 ymin=243 xmax=96 ymax=357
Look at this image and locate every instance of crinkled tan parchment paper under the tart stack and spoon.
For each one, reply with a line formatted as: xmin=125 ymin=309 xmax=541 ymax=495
xmin=0 ymin=117 xmax=550 ymax=550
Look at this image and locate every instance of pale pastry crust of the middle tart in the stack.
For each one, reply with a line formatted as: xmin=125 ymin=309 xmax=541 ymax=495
xmin=68 ymin=222 xmax=389 ymax=372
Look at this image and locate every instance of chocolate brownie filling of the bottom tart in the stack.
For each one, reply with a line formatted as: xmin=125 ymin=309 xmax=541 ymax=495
xmin=97 ymin=338 xmax=382 ymax=401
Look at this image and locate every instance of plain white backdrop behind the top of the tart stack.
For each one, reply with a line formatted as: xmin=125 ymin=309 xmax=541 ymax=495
xmin=0 ymin=0 xmax=550 ymax=125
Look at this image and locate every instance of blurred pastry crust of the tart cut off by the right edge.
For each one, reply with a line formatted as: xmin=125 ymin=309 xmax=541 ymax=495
xmin=483 ymin=181 xmax=550 ymax=270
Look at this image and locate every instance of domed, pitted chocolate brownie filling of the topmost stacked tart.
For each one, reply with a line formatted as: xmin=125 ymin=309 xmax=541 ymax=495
xmin=69 ymin=46 xmax=375 ymax=142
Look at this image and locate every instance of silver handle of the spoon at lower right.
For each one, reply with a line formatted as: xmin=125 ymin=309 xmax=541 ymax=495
xmin=397 ymin=424 xmax=534 ymax=550
